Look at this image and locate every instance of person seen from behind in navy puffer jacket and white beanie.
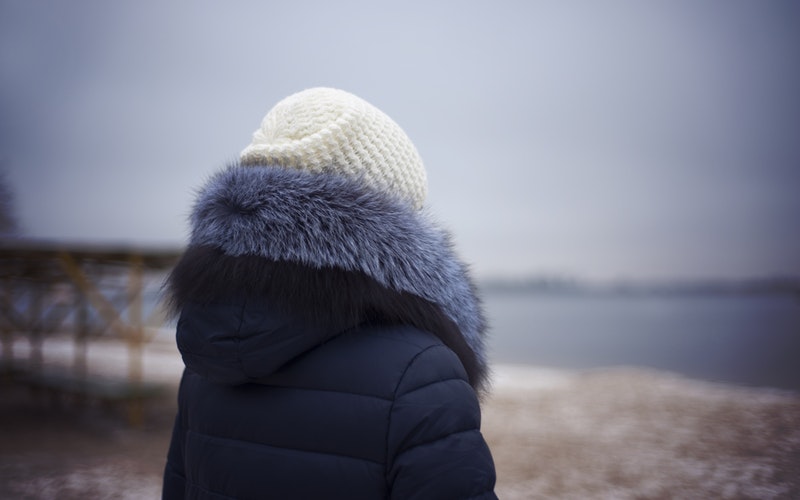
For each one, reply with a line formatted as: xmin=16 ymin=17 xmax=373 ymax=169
xmin=163 ymin=88 xmax=495 ymax=499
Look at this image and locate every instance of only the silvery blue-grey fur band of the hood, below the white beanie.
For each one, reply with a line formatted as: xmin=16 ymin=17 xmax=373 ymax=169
xmin=191 ymin=164 xmax=486 ymax=365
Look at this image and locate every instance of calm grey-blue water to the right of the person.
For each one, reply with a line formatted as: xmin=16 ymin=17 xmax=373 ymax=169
xmin=484 ymin=292 xmax=800 ymax=390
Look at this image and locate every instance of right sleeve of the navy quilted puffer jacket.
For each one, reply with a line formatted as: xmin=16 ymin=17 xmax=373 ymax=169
xmin=387 ymin=345 xmax=497 ymax=499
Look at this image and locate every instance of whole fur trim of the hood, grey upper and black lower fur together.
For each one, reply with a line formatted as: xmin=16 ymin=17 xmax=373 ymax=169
xmin=167 ymin=164 xmax=487 ymax=387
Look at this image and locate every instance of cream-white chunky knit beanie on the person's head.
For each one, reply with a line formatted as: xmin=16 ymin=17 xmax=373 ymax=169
xmin=240 ymin=87 xmax=428 ymax=209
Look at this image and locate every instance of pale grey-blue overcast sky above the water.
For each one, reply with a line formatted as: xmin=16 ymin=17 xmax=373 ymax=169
xmin=0 ymin=0 xmax=800 ymax=279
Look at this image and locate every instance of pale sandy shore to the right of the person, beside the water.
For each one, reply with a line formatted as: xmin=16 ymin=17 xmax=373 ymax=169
xmin=484 ymin=366 xmax=800 ymax=499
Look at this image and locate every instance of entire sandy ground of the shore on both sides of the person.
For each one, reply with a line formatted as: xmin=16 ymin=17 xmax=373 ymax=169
xmin=0 ymin=343 xmax=800 ymax=499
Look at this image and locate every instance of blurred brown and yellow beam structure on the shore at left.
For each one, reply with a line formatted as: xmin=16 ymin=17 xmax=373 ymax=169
xmin=0 ymin=240 xmax=181 ymax=426
